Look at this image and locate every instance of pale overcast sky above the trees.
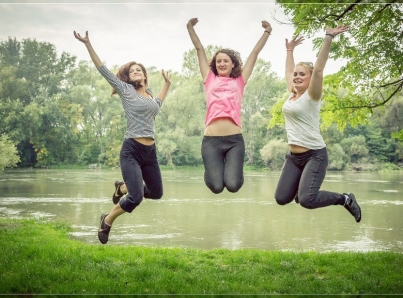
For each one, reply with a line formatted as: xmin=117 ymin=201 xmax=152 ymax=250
xmin=0 ymin=0 xmax=341 ymax=78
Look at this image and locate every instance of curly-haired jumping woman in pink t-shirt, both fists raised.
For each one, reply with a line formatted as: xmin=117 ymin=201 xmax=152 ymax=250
xmin=187 ymin=18 xmax=272 ymax=193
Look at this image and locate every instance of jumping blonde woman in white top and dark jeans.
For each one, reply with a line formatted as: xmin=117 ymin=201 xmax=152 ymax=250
xmin=274 ymin=26 xmax=361 ymax=222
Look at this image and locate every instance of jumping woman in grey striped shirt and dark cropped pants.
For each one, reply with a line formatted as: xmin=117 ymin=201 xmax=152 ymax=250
xmin=74 ymin=31 xmax=171 ymax=244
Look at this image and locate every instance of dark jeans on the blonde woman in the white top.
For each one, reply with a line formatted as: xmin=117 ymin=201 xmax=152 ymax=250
xmin=274 ymin=147 xmax=342 ymax=209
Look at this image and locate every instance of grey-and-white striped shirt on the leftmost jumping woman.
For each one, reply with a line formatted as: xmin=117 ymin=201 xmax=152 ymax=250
xmin=98 ymin=65 xmax=162 ymax=139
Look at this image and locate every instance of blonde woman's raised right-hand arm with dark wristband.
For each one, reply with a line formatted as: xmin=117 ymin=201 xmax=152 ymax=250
xmin=308 ymin=25 xmax=348 ymax=100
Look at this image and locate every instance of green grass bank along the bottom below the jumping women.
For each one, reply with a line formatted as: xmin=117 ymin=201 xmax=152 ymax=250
xmin=0 ymin=218 xmax=403 ymax=295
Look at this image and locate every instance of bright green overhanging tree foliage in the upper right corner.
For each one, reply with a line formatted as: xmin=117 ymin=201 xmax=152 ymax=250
xmin=278 ymin=0 xmax=403 ymax=135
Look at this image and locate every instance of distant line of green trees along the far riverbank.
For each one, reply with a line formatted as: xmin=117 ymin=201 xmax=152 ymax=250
xmin=0 ymin=38 xmax=403 ymax=170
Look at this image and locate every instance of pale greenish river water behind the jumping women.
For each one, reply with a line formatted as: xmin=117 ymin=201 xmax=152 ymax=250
xmin=0 ymin=170 xmax=403 ymax=252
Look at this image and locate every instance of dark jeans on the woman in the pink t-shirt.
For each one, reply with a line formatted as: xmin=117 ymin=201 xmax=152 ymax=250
xmin=201 ymin=134 xmax=245 ymax=194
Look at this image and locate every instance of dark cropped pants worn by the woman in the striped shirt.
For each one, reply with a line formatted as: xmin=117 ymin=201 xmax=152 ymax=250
xmin=119 ymin=139 xmax=163 ymax=213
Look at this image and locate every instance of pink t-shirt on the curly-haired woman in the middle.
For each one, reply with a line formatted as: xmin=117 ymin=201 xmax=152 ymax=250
xmin=204 ymin=70 xmax=245 ymax=127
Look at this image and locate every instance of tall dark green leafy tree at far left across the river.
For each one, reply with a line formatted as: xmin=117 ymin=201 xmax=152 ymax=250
xmin=0 ymin=38 xmax=75 ymax=166
